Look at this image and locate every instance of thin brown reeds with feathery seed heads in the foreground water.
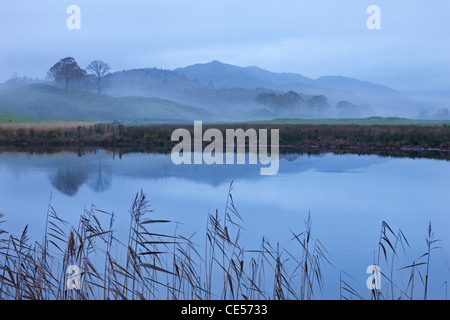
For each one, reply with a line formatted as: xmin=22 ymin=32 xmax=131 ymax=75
xmin=0 ymin=184 xmax=444 ymax=300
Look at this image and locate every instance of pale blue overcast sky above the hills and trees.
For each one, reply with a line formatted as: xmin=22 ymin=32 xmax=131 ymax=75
xmin=0 ymin=0 xmax=450 ymax=90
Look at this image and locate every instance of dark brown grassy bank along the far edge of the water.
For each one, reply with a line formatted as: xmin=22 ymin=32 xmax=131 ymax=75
xmin=0 ymin=122 xmax=450 ymax=151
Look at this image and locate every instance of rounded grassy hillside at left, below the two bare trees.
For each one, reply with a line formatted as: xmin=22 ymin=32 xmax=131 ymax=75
xmin=0 ymin=84 xmax=213 ymax=123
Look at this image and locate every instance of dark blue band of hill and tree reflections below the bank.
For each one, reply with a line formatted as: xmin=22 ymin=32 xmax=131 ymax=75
xmin=0 ymin=151 xmax=389 ymax=196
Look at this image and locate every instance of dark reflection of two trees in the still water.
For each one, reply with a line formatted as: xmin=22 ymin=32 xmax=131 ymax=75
xmin=50 ymin=161 xmax=112 ymax=196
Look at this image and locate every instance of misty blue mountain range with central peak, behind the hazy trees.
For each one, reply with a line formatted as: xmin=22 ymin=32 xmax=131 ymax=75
xmin=107 ymin=60 xmax=420 ymax=120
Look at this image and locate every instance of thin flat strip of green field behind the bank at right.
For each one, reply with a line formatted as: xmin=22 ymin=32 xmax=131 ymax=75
xmin=246 ymin=117 xmax=450 ymax=126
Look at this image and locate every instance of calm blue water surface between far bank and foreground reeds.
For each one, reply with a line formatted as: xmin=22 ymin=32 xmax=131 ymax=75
xmin=0 ymin=151 xmax=450 ymax=299
